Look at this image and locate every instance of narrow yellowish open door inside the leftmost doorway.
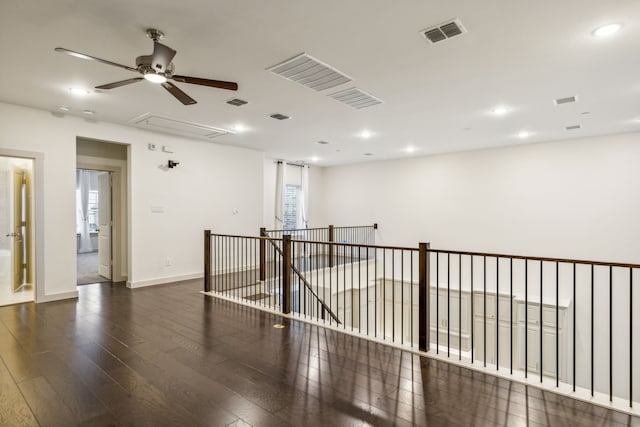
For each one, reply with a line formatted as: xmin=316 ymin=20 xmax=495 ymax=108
xmin=11 ymin=169 xmax=26 ymax=291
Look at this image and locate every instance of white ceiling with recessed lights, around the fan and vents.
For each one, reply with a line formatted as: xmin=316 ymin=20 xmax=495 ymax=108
xmin=0 ymin=0 xmax=640 ymax=165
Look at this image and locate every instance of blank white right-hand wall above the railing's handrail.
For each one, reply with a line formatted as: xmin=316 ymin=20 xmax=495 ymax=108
xmin=323 ymin=133 xmax=640 ymax=263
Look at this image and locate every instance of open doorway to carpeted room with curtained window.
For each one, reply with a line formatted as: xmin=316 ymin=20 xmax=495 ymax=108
xmin=76 ymin=169 xmax=113 ymax=285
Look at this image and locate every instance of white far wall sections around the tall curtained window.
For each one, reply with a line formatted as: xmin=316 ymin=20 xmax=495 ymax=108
xmin=256 ymin=157 xmax=328 ymax=232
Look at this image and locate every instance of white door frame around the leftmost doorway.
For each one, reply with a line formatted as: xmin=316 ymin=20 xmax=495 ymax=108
xmin=0 ymin=147 xmax=45 ymax=302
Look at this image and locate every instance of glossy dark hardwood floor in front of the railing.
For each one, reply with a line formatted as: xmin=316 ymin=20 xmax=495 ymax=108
xmin=0 ymin=281 xmax=640 ymax=426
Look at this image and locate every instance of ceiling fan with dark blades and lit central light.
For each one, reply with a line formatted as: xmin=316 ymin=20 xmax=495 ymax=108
xmin=55 ymin=28 xmax=238 ymax=105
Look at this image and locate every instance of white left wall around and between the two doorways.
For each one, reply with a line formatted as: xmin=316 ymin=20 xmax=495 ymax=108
xmin=0 ymin=103 xmax=264 ymax=301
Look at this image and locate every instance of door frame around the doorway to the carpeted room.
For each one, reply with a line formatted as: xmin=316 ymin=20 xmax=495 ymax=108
xmin=76 ymin=160 xmax=131 ymax=282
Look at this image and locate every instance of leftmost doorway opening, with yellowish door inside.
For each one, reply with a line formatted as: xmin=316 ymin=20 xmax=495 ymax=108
xmin=0 ymin=156 xmax=35 ymax=305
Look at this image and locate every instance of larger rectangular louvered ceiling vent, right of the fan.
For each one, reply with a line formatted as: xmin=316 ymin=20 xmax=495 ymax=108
xmin=267 ymin=53 xmax=353 ymax=91
